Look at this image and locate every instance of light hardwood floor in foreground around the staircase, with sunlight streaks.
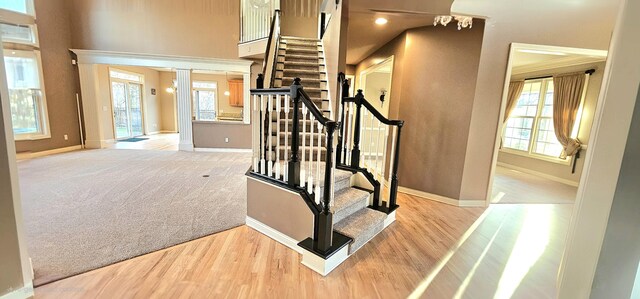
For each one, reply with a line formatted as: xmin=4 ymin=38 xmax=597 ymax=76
xmin=36 ymin=194 xmax=572 ymax=298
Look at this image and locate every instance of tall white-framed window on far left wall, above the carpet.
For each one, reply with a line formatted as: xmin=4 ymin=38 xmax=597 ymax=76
xmin=4 ymin=50 xmax=51 ymax=140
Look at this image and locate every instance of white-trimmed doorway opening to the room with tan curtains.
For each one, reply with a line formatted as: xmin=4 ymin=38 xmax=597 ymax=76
xmin=488 ymin=44 xmax=607 ymax=204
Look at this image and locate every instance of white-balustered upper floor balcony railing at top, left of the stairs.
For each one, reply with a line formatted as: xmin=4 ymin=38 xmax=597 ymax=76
xmin=240 ymin=0 xmax=280 ymax=43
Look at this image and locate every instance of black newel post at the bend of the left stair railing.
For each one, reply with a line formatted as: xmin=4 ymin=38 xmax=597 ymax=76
xmin=288 ymin=78 xmax=302 ymax=186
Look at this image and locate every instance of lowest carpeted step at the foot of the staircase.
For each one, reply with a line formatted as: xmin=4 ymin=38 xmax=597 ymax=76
xmin=333 ymin=208 xmax=387 ymax=254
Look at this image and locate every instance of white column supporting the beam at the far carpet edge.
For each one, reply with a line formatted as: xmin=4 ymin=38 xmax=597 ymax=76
xmin=176 ymin=70 xmax=193 ymax=151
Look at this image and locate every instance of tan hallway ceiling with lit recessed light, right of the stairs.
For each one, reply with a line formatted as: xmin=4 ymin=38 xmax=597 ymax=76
xmin=347 ymin=0 xmax=453 ymax=64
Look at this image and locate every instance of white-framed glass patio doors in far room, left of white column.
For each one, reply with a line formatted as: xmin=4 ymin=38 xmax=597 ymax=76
xmin=109 ymin=69 xmax=145 ymax=140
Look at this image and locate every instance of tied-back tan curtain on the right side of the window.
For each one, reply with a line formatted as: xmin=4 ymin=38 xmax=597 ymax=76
xmin=553 ymin=72 xmax=585 ymax=159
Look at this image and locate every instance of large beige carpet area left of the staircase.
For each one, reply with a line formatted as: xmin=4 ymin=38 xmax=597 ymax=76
xmin=18 ymin=150 xmax=251 ymax=285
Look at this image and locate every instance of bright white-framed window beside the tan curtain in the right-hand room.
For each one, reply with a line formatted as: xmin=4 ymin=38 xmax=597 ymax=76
xmin=503 ymin=78 xmax=580 ymax=161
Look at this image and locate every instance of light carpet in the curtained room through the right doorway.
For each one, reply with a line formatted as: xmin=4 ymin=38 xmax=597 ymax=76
xmin=491 ymin=166 xmax=578 ymax=204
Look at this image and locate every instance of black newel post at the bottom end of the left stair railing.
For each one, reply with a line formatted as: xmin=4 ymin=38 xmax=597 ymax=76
xmin=314 ymin=121 xmax=337 ymax=252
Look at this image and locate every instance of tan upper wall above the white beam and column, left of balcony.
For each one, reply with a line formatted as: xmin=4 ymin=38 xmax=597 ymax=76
xmin=69 ymin=0 xmax=240 ymax=58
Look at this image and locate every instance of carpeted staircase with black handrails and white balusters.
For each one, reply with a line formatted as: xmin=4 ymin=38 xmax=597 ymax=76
xmin=247 ymin=12 xmax=403 ymax=275
